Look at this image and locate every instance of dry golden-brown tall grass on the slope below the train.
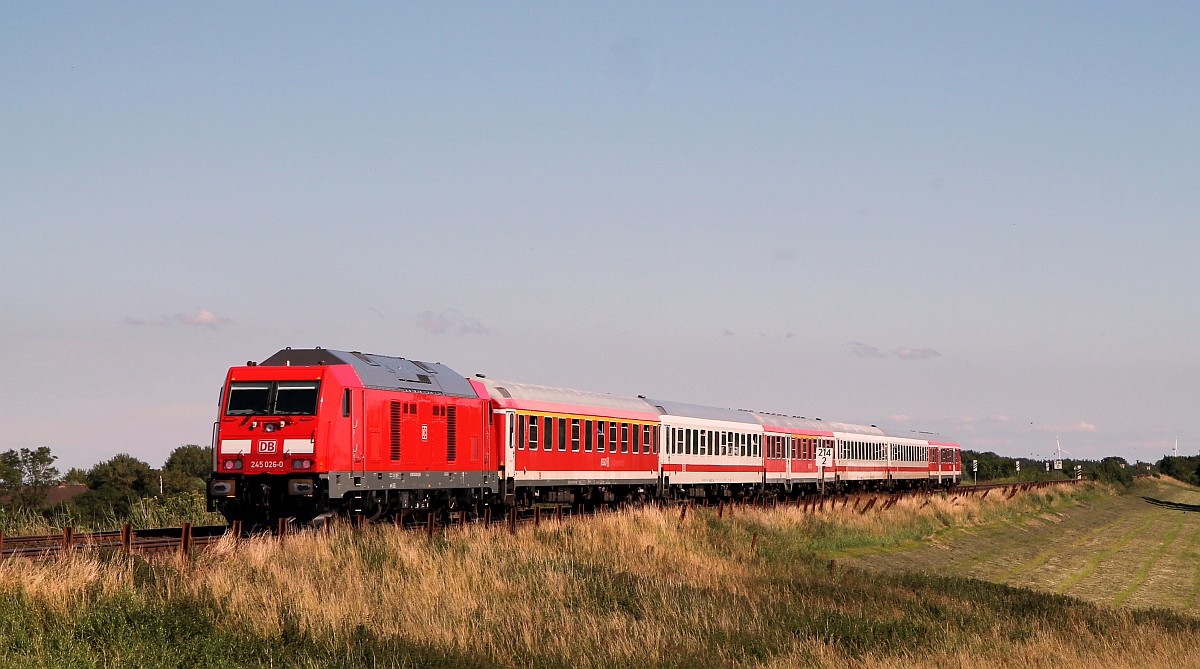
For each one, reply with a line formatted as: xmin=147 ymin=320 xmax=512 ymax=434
xmin=0 ymin=488 xmax=1200 ymax=669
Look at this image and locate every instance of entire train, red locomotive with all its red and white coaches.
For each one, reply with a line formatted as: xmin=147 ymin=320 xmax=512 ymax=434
xmin=208 ymin=349 xmax=961 ymax=525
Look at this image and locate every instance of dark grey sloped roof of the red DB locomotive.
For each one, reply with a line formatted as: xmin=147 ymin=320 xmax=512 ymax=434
xmin=259 ymin=349 xmax=479 ymax=397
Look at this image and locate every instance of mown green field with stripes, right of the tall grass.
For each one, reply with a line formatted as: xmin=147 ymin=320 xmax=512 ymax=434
xmin=847 ymin=478 xmax=1200 ymax=613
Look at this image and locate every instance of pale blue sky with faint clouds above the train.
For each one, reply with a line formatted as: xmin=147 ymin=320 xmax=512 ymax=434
xmin=0 ymin=2 xmax=1200 ymax=469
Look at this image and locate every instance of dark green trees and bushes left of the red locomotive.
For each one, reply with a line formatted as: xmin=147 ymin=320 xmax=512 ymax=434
xmin=0 ymin=444 xmax=212 ymax=518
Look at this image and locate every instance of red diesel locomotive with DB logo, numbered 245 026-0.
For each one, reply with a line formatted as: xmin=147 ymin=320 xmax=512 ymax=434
xmin=209 ymin=349 xmax=498 ymax=523
